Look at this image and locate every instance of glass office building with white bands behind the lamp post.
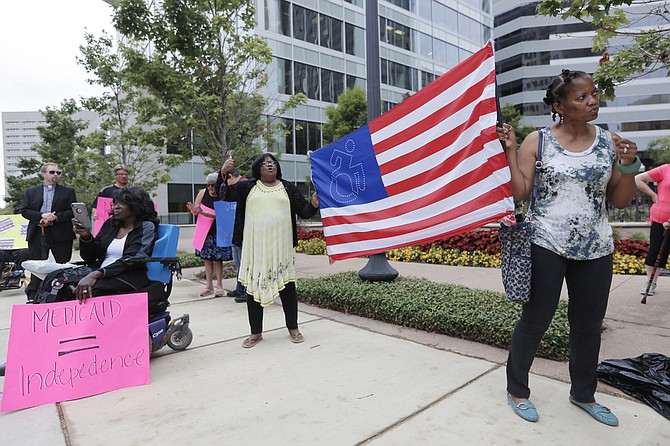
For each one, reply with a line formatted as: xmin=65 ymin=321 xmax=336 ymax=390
xmin=256 ymin=0 xmax=493 ymax=186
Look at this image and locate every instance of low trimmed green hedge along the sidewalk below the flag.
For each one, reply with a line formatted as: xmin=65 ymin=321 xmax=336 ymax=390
xmin=298 ymin=272 xmax=569 ymax=361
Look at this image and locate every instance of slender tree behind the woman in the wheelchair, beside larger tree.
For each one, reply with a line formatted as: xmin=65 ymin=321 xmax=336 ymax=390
xmin=77 ymin=33 xmax=190 ymax=192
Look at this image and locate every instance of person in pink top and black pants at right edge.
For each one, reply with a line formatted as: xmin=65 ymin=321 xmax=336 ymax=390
xmin=635 ymin=164 xmax=670 ymax=296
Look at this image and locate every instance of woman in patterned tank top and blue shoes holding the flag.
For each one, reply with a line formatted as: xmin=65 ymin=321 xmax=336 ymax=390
xmin=497 ymin=70 xmax=640 ymax=426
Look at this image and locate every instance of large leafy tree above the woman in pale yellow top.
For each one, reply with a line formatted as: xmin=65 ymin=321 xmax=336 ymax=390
xmin=114 ymin=0 xmax=306 ymax=172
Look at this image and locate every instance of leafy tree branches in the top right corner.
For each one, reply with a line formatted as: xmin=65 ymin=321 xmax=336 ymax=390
xmin=537 ymin=0 xmax=670 ymax=99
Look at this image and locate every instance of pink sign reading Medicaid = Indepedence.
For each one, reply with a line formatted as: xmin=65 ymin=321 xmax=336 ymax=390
xmin=0 ymin=293 xmax=150 ymax=412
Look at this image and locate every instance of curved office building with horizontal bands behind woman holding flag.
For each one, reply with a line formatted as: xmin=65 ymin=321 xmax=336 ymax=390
xmin=493 ymin=0 xmax=670 ymax=157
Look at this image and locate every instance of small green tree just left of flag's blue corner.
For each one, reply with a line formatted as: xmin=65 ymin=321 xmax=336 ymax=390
xmin=323 ymin=87 xmax=368 ymax=143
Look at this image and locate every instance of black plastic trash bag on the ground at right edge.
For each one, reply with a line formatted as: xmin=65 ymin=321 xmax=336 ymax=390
xmin=597 ymin=353 xmax=670 ymax=420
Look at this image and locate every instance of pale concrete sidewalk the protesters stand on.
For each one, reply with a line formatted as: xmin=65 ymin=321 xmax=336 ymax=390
xmin=0 ymin=255 xmax=670 ymax=446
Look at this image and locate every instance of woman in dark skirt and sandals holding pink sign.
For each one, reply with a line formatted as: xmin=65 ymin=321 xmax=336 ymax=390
xmin=186 ymin=173 xmax=232 ymax=297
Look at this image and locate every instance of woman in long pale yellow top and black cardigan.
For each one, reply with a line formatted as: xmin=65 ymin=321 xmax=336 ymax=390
xmin=217 ymin=153 xmax=319 ymax=348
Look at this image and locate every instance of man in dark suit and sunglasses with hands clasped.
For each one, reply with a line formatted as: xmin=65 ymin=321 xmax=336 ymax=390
xmin=20 ymin=163 xmax=77 ymax=263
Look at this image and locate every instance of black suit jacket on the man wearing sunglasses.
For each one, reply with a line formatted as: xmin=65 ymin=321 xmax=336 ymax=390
xmin=19 ymin=184 xmax=77 ymax=241
